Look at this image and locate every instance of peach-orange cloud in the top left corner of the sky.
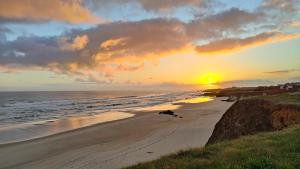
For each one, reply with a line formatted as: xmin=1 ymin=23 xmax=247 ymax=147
xmin=0 ymin=0 xmax=98 ymax=24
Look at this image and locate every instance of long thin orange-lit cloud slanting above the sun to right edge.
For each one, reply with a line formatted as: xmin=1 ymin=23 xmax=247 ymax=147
xmin=196 ymin=32 xmax=300 ymax=54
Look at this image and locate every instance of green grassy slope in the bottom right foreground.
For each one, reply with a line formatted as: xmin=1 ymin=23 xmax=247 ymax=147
xmin=127 ymin=125 xmax=300 ymax=169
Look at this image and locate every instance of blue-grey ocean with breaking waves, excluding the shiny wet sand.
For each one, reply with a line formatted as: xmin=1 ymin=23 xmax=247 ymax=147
xmin=0 ymin=91 xmax=201 ymax=129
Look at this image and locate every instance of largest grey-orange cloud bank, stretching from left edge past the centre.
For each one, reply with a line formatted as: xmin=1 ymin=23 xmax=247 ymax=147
xmin=0 ymin=19 xmax=190 ymax=78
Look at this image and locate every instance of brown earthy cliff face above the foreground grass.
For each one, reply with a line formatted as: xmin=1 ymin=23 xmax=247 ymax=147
xmin=207 ymin=99 xmax=300 ymax=144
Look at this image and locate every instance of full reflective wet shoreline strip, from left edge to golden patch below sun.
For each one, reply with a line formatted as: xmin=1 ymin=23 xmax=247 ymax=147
xmin=0 ymin=96 xmax=213 ymax=146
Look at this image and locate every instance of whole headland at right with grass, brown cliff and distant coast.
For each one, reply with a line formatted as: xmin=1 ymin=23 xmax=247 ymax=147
xmin=128 ymin=88 xmax=300 ymax=169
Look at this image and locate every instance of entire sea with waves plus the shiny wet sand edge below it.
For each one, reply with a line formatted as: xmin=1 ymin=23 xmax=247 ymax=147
xmin=0 ymin=92 xmax=209 ymax=144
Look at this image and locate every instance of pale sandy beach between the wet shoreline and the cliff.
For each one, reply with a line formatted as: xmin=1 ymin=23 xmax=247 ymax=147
xmin=0 ymin=98 xmax=232 ymax=169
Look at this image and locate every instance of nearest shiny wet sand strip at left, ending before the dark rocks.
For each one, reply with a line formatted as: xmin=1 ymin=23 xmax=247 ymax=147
xmin=0 ymin=111 xmax=136 ymax=146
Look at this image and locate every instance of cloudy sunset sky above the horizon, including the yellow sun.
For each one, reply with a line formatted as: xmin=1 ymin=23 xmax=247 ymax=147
xmin=0 ymin=0 xmax=300 ymax=91
